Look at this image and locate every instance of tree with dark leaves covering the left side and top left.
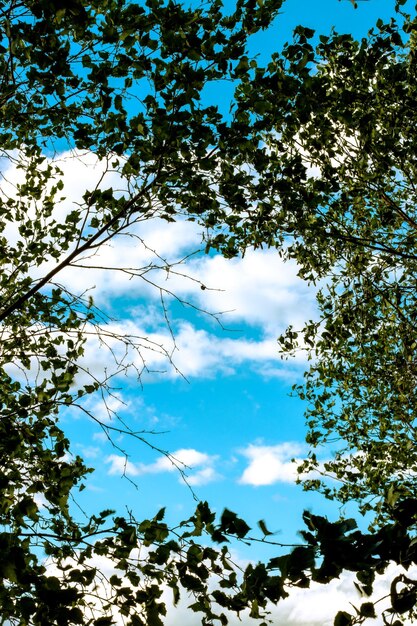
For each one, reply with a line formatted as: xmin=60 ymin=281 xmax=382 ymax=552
xmin=0 ymin=0 xmax=290 ymax=626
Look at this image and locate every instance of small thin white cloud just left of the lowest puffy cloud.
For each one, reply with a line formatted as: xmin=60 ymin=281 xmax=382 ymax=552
xmin=106 ymin=448 xmax=220 ymax=486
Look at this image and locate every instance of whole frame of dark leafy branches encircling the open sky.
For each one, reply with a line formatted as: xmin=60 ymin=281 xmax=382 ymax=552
xmin=0 ymin=0 xmax=417 ymax=626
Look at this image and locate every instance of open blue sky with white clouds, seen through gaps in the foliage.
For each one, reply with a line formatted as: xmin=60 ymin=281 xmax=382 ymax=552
xmin=3 ymin=0 xmax=410 ymax=625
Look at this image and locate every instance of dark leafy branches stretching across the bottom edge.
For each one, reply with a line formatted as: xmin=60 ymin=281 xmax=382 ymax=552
xmin=4 ymin=492 xmax=417 ymax=626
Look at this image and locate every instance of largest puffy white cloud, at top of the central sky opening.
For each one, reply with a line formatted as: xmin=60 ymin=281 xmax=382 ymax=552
xmin=60 ymin=218 xmax=316 ymax=348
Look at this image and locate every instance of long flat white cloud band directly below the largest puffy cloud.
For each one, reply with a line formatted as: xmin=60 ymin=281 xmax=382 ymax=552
xmin=74 ymin=317 xmax=306 ymax=386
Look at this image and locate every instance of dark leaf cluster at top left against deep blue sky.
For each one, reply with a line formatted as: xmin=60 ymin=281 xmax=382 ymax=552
xmin=0 ymin=0 xmax=282 ymax=278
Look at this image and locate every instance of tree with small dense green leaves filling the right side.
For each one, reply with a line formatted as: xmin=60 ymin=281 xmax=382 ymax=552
xmin=210 ymin=2 xmax=417 ymax=519
